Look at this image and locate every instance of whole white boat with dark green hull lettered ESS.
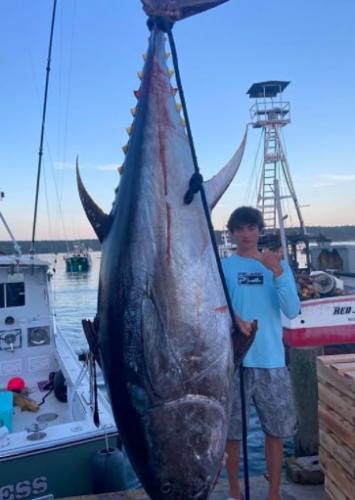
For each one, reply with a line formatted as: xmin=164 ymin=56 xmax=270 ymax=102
xmin=0 ymin=212 xmax=117 ymax=499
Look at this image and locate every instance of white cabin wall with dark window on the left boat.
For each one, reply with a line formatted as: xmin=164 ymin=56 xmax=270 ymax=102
xmin=0 ymin=257 xmax=58 ymax=389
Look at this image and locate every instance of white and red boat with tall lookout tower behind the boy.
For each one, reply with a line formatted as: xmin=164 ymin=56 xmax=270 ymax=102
xmin=238 ymin=81 xmax=355 ymax=348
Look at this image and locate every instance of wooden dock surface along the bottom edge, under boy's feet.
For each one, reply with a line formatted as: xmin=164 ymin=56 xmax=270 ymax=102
xmin=62 ymin=476 xmax=327 ymax=500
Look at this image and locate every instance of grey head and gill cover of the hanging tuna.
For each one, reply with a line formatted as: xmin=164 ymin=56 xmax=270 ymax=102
xmin=147 ymin=395 xmax=227 ymax=499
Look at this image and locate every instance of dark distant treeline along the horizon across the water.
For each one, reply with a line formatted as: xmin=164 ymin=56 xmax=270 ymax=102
xmin=0 ymin=226 xmax=355 ymax=255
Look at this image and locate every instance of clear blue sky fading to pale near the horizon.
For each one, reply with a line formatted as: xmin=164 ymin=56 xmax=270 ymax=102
xmin=0 ymin=0 xmax=355 ymax=240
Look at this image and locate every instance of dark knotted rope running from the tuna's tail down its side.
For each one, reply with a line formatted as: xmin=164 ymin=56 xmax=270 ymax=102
xmin=148 ymin=17 xmax=250 ymax=500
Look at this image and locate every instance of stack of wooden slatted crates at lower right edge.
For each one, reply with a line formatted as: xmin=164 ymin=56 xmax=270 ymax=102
xmin=317 ymin=354 xmax=355 ymax=500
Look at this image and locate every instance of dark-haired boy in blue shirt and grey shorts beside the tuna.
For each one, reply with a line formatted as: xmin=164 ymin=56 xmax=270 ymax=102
xmin=222 ymin=207 xmax=300 ymax=500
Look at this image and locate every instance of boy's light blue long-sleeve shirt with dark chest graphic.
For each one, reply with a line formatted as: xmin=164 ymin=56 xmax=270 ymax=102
xmin=222 ymin=254 xmax=300 ymax=368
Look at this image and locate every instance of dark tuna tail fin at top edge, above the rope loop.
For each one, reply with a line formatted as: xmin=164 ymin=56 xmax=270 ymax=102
xmin=141 ymin=0 xmax=229 ymax=22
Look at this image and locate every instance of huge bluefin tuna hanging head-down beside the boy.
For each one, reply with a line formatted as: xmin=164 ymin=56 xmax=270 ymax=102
xmin=78 ymin=0 xmax=250 ymax=500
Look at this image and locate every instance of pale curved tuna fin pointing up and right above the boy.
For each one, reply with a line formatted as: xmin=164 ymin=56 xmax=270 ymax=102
xmin=204 ymin=129 xmax=248 ymax=210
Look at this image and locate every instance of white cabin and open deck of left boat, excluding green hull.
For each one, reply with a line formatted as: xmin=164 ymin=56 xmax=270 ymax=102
xmin=0 ymin=256 xmax=116 ymax=466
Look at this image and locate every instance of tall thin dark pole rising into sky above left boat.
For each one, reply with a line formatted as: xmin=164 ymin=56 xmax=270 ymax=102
xmin=30 ymin=0 xmax=57 ymax=255
